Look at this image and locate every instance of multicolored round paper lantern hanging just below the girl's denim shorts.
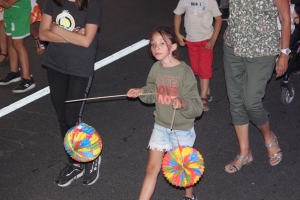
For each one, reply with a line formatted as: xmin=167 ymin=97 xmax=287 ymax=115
xmin=162 ymin=146 xmax=204 ymax=187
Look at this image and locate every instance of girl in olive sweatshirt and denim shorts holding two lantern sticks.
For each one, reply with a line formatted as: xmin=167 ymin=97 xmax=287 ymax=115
xmin=127 ymin=27 xmax=203 ymax=200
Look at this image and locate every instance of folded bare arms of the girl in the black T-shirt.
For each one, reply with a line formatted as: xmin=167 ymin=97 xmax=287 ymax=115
xmin=40 ymin=14 xmax=98 ymax=47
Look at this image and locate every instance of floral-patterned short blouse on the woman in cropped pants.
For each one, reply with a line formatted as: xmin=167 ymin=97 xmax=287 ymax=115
xmin=224 ymin=0 xmax=279 ymax=58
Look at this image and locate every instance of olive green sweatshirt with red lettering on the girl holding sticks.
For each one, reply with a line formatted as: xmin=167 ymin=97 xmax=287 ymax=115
xmin=139 ymin=61 xmax=203 ymax=130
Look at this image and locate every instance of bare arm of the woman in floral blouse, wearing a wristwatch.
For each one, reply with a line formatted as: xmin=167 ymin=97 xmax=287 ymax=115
xmin=275 ymin=0 xmax=291 ymax=77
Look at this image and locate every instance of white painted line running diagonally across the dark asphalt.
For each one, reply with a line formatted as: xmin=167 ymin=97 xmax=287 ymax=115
xmin=0 ymin=40 xmax=149 ymax=118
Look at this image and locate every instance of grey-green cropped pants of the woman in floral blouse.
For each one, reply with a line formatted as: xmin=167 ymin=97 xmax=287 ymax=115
xmin=223 ymin=44 xmax=275 ymax=126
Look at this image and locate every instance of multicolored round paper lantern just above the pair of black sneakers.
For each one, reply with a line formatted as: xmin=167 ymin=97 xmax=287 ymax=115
xmin=64 ymin=123 xmax=102 ymax=162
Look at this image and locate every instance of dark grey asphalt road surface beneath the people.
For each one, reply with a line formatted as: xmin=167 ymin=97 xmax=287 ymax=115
xmin=0 ymin=0 xmax=300 ymax=200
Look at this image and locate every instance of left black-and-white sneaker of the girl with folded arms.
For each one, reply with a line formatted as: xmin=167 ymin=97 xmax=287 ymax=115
xmin=55 ymin=164 xmax=84 ymax=187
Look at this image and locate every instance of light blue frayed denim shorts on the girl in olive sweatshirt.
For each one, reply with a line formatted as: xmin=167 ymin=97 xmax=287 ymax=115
xmin=148 ymin=124 xmax=196 ymax=151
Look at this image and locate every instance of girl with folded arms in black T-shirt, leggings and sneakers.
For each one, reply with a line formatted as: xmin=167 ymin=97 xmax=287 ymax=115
xmin=39 ymin=0 xmax=101 ymax=187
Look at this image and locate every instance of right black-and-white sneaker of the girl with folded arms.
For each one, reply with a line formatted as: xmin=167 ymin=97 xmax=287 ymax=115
xmin=83 ymin=156 xmax=101 ymax=185
